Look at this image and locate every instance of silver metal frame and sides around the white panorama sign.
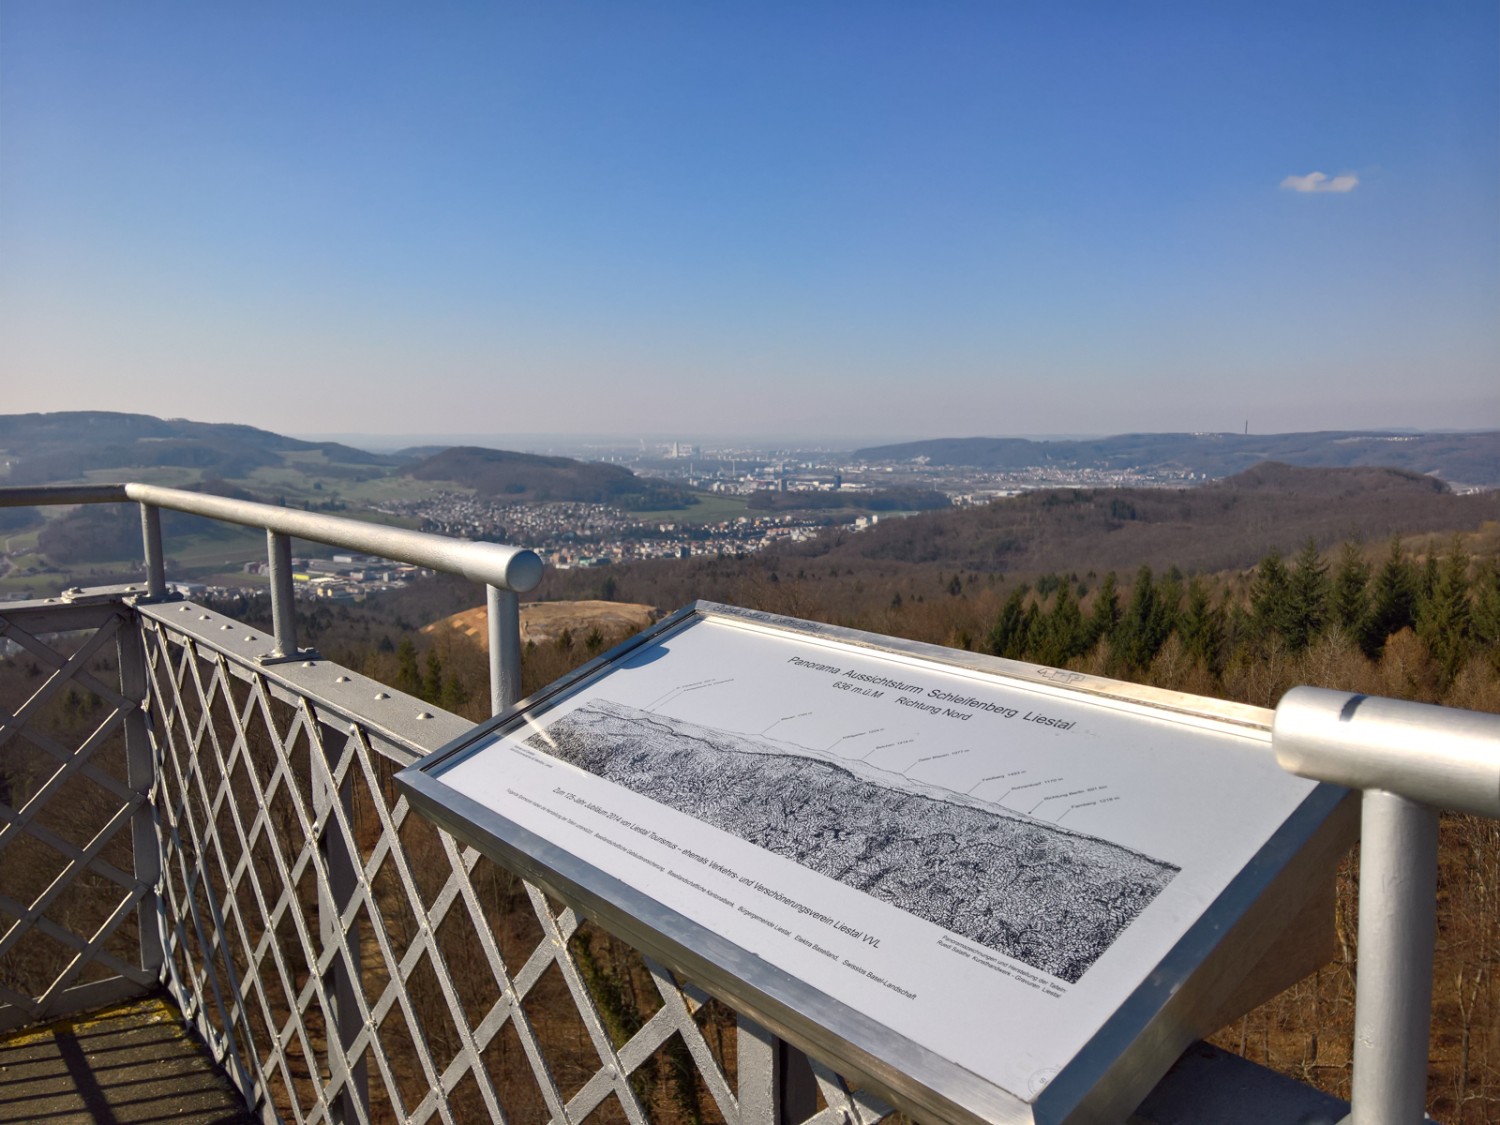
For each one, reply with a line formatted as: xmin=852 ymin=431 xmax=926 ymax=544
xmin=396 ymin=602 xmax=1355 ymax=1125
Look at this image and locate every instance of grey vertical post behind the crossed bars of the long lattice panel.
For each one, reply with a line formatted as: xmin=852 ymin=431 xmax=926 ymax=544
xmin=314 ymin=726 xmax=369 ymax=1125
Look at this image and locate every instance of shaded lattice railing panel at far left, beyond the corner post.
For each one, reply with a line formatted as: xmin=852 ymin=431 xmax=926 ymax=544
xmin=0 ymin=606 xmax=156 ymax=1028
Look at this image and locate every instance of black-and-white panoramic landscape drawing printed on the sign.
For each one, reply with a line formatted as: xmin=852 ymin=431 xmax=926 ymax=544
xmin=527 ymin=699 xmax=1181 ymax=983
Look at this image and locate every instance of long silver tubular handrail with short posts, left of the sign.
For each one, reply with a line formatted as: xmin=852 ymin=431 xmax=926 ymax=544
xmin=0 ymin=483 xmax=543 ymax=714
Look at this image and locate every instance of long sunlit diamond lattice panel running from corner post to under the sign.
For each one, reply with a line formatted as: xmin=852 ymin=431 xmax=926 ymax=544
xmin=135 ymin=621 xmax=885 ymax=1125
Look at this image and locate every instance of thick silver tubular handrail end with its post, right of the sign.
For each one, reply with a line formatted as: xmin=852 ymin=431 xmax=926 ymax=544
xmin=1271 ymin=687 xmax=1500 ymax=1125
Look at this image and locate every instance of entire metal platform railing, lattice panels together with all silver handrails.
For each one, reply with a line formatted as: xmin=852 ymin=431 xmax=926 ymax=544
xmin=0 ymin=485 xmax=1500 ymax=1125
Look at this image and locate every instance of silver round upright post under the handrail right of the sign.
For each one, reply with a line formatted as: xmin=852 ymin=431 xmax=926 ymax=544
xmin=1349 ymin=789 xmax=1437 ymax=1125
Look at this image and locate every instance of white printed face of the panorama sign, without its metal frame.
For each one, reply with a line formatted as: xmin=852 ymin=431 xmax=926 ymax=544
xmin=438 ymin=617 xmax=1313 ymax=1101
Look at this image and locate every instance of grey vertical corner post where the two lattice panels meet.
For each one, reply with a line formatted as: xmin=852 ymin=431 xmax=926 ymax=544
xmin=116 ymin=609 xmax=165 ymax=974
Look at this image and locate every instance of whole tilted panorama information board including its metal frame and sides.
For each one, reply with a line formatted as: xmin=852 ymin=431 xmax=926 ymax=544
xmin=399 ymin=603 xmax=1343 ymax=1122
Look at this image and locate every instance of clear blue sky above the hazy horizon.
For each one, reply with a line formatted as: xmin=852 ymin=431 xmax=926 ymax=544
xmin=0 ymin=0 xmax=1500 ymax=438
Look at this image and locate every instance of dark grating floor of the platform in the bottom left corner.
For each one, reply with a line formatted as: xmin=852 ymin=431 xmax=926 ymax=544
xmin=0 ymin=996 xmax=257 ymax=1125
